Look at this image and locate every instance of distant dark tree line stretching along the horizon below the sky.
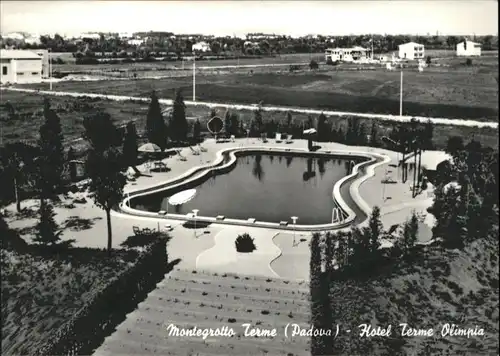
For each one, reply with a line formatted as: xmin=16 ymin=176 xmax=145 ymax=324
xmin=1 ymin=33 xmax=498 ymax=54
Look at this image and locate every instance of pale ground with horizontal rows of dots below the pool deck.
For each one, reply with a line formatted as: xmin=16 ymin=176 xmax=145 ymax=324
xmin=95 ymin=269 xmax=310 ymax=356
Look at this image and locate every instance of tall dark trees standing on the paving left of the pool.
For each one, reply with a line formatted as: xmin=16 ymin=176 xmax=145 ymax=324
xmin=1 ymin=99 xmax=131 ymax=251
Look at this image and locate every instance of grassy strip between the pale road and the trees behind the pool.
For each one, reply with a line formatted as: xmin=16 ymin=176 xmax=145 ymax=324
xmin=0 ymin=91 xmax=499 ymax=149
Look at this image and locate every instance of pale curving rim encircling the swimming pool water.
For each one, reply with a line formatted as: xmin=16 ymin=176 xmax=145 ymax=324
xmin=118 ymin=146 xmax=391 ymax=231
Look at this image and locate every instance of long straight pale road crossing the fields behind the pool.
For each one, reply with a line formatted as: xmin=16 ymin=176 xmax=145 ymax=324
xmin=0 ymin=87 xmax=498 ymax=129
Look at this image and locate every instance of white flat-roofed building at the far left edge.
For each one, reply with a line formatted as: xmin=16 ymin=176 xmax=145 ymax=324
xmin=0 ymin=49 xmax=42 ymax=84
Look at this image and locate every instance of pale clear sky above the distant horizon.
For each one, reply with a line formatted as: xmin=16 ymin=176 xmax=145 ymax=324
xmin=0 ymin=0 xmax=498 ymax=36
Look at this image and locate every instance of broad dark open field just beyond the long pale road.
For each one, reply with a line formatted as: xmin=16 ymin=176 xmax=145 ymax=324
xmin=17 ymin=60 xmax=498 ymax=121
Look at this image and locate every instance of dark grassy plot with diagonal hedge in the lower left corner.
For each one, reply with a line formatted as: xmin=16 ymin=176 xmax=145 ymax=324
xmin=2 ymin=236 xmax=166 ymax=355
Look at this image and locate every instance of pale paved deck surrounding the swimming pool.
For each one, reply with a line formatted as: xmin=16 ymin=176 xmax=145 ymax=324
xmin=7 ymin=138 xmax=440 ymax=279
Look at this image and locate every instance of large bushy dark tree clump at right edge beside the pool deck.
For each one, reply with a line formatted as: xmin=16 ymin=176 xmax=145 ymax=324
xmin=429 ymin=137 xmax=498 ymax=248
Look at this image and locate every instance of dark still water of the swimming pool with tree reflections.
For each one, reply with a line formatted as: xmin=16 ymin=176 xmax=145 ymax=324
xmin=131 ymin=153 xmax=368 ymax=225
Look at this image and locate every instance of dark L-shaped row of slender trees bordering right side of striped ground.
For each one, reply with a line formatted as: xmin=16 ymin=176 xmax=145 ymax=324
xmin=309 ymin=207 xmax=418 ymax=355
